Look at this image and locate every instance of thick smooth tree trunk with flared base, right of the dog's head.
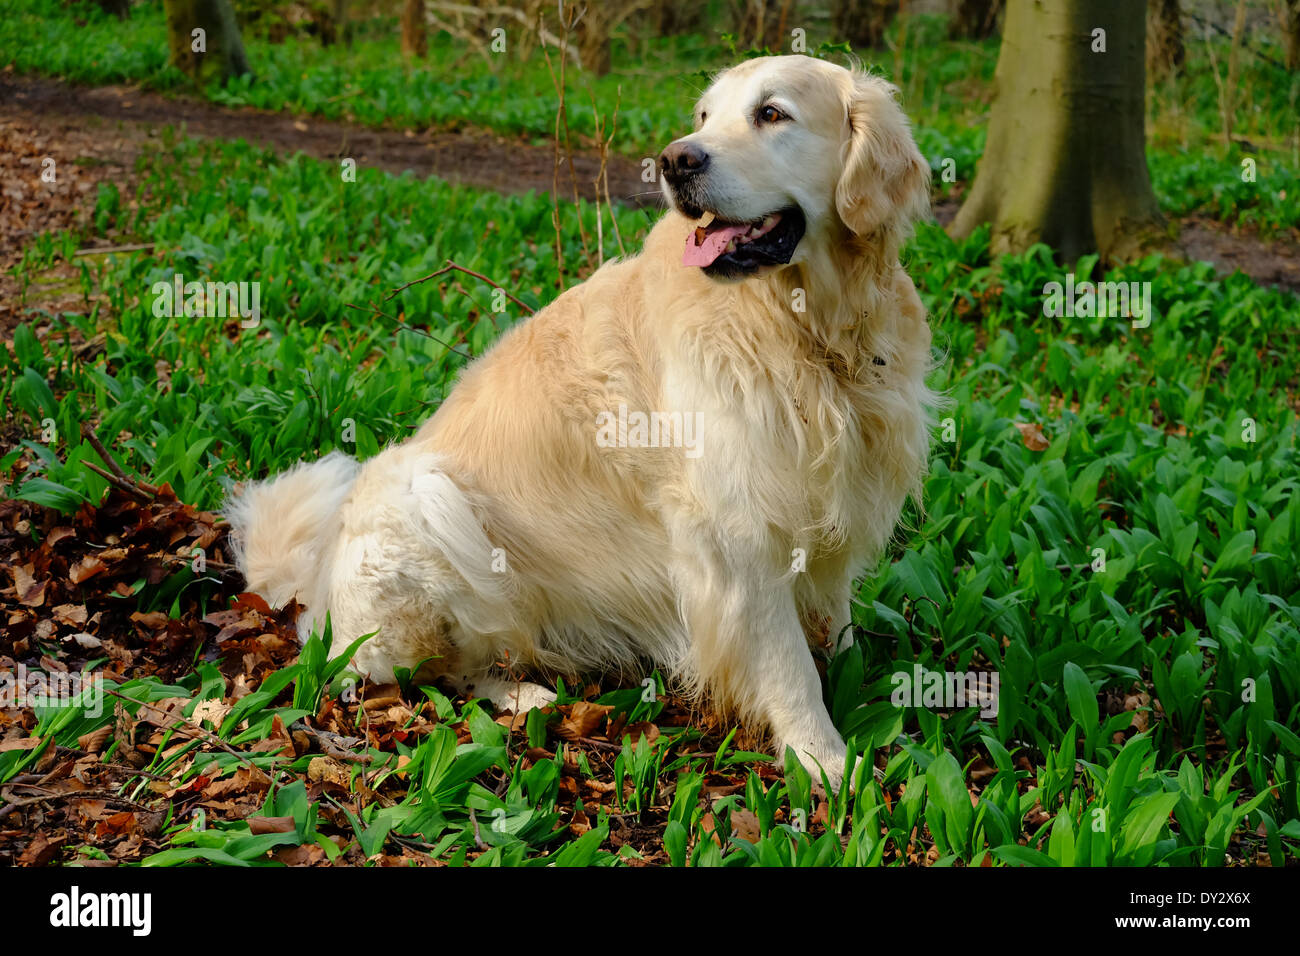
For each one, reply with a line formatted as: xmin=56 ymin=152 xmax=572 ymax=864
xmin=950 ymin=0 xmax=1162 ymax=260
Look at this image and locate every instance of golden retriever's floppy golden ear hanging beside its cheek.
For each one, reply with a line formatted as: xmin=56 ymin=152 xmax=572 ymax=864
xmin=835 ymin=73 xmax=930 ymax=239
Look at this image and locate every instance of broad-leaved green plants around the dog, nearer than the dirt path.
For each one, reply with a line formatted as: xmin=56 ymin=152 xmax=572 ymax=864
xmin=0 ymin=123 xmax=1300 ymax=866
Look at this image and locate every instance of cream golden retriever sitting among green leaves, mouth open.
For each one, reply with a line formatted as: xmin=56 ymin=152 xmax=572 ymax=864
xmin=226 ymin=56 xmax=936 ymax=783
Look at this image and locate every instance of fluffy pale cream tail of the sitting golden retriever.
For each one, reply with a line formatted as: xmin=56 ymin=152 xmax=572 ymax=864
xmin=224 ymin=451 xmax=361 ymax=633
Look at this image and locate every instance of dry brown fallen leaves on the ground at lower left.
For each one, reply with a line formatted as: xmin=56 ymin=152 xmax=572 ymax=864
xmin=0 ymin=485 xmax=818 ymax=866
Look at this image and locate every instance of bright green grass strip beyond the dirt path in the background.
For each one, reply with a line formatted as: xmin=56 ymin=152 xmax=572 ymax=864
xmin=0 ymin=0 xmax=1300 ymax=234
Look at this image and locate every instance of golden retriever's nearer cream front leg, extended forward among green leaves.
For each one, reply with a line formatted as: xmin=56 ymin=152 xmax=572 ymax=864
xmin=679 ymin=537 xmax=845 ymax=787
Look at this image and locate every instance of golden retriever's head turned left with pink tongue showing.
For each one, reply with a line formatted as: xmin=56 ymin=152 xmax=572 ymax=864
xmin=659 ymin=56 xmax=930 ymax=278
